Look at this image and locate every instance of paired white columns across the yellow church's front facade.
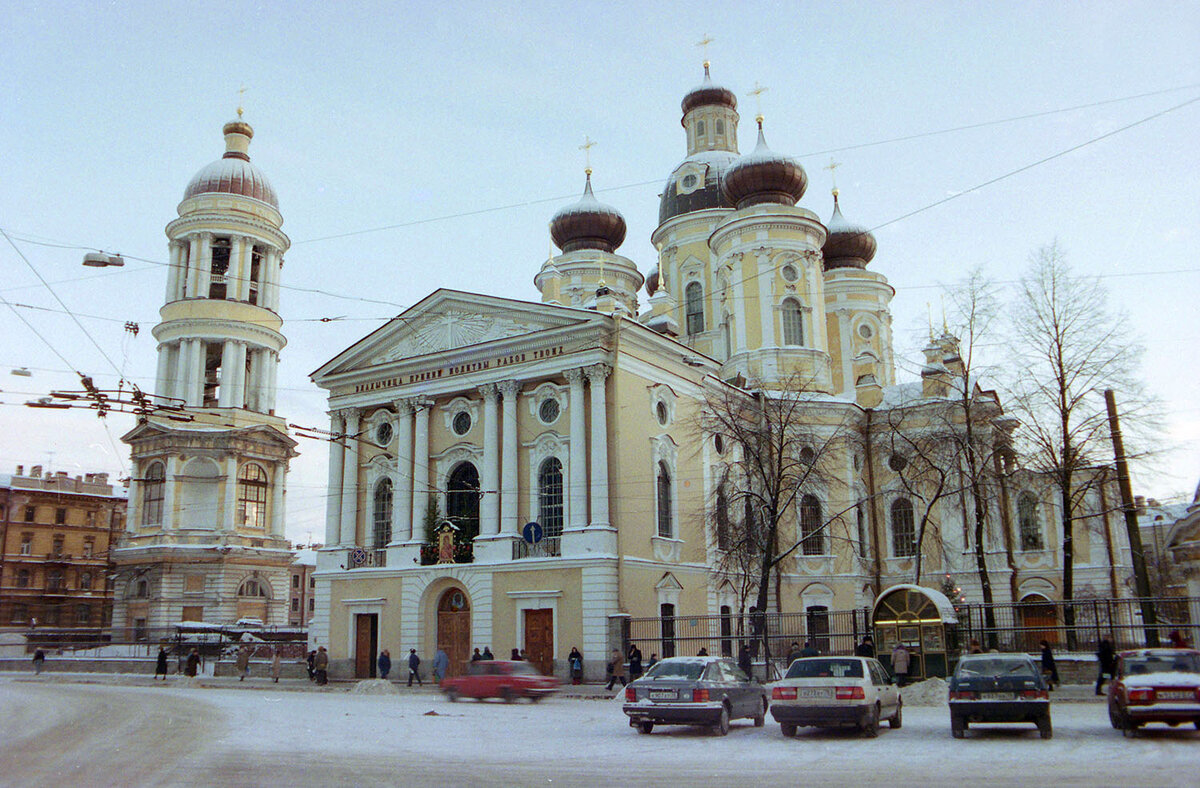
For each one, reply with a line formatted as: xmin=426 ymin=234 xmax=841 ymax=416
xmin=325 ymin=363 xmax=612 ymax=547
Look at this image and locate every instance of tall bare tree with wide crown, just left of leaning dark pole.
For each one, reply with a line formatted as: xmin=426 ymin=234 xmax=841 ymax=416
xmin=1012 ymin=243 xmax=1141 ymax=646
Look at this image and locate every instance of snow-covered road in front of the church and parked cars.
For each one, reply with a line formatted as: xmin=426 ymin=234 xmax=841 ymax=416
xmin=0 ymin=679 xmax=1200 ymax=787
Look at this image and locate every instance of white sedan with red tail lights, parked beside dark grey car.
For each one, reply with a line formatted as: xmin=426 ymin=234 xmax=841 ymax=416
xmin=770 ymin=657 xmax=902 ymax=738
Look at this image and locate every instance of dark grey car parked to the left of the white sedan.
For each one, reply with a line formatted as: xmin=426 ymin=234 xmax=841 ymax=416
xmin=623 ymin=657 xmax=769 ymax=736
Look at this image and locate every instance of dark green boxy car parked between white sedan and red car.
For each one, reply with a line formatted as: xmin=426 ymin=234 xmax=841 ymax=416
xmin=950 ymin=654 xmax=1054 ymax=739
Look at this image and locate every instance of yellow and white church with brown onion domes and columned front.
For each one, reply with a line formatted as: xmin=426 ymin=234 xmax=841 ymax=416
xmin=309 ymin=64 xmax=1128 ymax=678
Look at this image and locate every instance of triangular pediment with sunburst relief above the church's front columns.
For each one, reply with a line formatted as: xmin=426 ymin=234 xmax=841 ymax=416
xmin=312 ymin=289 xmax=604 ymax=383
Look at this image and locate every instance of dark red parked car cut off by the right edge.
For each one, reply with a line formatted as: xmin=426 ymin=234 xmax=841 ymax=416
xmin=1109 ymin=649 xmax=1200 ymax=736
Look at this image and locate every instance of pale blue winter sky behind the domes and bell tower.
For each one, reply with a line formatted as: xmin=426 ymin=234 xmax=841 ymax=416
xmin=0 ymin=0 xmax=1200 ymax=542
